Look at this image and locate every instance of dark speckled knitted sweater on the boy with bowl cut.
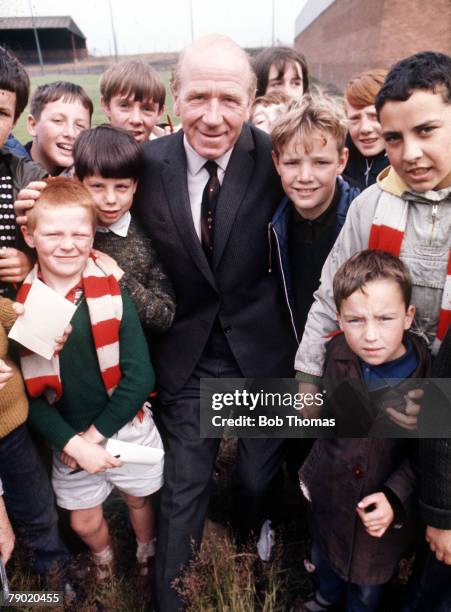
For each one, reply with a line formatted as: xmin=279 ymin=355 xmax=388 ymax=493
xmin=94 ymin=217 xmax=175 ymax=332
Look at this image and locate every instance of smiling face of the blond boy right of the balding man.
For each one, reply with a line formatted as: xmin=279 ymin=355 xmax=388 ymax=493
xmin=273 ymin=131 xmax=348 ymax=220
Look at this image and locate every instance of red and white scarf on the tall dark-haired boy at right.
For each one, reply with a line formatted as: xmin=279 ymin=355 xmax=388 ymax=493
xmin=368 ymin=194 xmax=451 ymax=354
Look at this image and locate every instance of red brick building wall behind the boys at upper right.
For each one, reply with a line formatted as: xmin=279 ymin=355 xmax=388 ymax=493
xmin=295 ymin=0 xmax=451 ymax=88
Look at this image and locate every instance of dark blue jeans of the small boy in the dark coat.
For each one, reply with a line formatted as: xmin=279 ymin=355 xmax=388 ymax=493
xmin=312 ymin=544 xmax=385 ymax=612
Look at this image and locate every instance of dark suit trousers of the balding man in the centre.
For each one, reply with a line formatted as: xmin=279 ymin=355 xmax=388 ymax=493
xmin=155 ymin=333 xmax=284 ymax=612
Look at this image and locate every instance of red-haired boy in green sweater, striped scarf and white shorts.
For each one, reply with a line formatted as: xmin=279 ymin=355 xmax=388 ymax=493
xmin=18 ymin=177 xmax=162 ymax=579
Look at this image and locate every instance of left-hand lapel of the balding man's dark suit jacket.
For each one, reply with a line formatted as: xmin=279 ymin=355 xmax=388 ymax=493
xmin=163 ymin=130 xmax=216 ymax=286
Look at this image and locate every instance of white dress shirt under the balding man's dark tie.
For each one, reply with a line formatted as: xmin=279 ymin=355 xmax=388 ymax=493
xmin=183 ymin=136 xmax=233 ymax=240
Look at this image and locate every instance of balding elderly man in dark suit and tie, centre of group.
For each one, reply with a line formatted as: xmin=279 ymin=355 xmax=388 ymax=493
xmin=135 ymin=35 xmax=296 ymax=612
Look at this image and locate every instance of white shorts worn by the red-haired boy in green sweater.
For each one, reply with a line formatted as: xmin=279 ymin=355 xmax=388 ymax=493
xmin=52 ymin=405 xmax=163 ymax=510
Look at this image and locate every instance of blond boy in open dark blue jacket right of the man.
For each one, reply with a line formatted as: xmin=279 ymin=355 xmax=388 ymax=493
xmin=271 ymin=94 xmax=359 ymax=339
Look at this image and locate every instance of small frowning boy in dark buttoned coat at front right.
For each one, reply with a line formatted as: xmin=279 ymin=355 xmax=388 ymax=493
xmin=299 ymin=250 xmax=424 ymax=612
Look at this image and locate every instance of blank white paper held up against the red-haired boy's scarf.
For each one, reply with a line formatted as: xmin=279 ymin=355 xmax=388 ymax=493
xmin=8 ymin=279 xmax=76 ymax=359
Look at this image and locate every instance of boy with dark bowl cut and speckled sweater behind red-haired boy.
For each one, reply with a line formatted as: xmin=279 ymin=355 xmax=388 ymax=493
xmin=74 ymin=125 xmax=175 ymax=332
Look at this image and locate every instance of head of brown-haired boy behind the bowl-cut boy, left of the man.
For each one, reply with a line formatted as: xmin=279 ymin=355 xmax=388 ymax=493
xmin=100 ymin=59 xmax=166 ymax=143
